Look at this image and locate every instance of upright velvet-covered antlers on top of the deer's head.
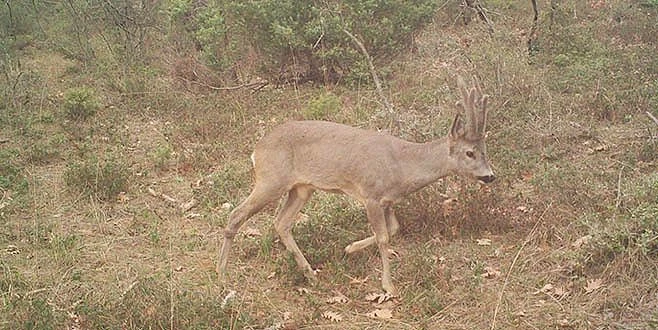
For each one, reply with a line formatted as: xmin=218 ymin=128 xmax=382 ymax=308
xmin=457 ymin=76 xmax=489 ymax=140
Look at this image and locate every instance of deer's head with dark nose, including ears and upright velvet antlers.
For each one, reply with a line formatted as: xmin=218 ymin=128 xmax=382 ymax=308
xmin=448 ymin=77 xmax=495 ymax=183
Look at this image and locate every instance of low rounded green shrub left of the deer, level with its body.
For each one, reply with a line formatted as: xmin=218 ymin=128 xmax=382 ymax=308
xmin=64 ymin=157 xmax=130 ymax=200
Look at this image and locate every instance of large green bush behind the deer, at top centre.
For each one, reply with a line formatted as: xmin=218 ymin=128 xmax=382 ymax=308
xmin=168 ymin=0 xmax=437 ymax=82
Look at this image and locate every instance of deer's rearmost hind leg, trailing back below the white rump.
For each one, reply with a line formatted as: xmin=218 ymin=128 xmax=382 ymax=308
xmin=217 ymin=183 xmax=285 ymax=277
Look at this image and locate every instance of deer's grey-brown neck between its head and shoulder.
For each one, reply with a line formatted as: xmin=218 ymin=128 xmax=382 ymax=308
xmin=401 ymin=138 xmax=454 ymax=193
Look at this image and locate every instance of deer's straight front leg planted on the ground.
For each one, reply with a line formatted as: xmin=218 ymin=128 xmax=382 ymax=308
xmin=366 ymin=201 xmax=398 ymax=297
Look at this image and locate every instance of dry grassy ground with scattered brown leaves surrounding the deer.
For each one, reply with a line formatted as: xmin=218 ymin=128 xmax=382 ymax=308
xmin=0 ymin=1 xmax=658 ymax=329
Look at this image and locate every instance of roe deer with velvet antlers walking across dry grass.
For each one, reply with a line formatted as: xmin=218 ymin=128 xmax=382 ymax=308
xmin=217 ymin=78 xmax=494 ymax=296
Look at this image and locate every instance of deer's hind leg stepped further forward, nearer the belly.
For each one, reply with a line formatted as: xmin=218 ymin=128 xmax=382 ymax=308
xmin=274 ymin=186 xmax=315 ymax=280
